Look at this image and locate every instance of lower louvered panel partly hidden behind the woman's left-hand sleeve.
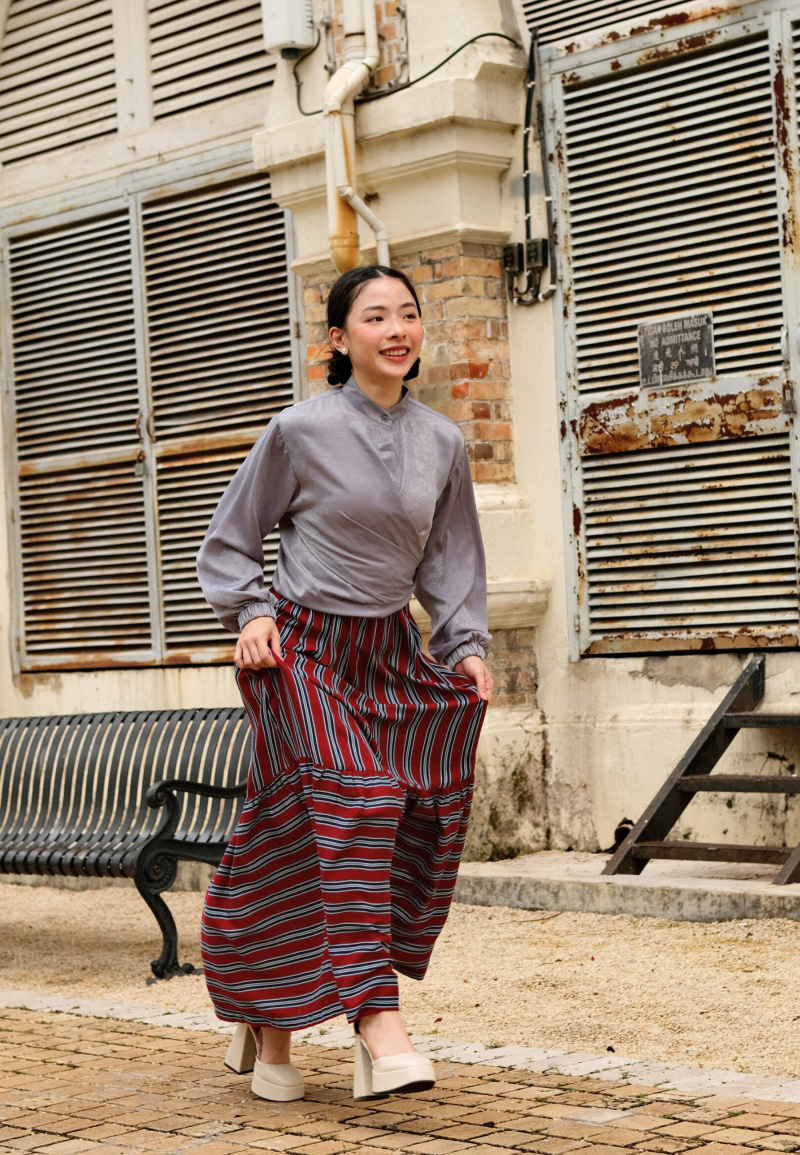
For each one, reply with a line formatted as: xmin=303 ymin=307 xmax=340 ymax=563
xmin=158 ymin=447 xmax=278 ymax=661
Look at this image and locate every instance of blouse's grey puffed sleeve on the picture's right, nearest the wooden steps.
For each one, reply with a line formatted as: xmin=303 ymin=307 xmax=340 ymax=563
xmin=414 ymin=445 xmax=492 ymax=669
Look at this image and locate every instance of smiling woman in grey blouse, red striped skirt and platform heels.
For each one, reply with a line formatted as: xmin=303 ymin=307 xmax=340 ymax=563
xmin=197 ymin=266 xmax=492 ymax=1100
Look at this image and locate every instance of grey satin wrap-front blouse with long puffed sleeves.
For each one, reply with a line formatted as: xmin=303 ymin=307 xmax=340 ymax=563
xmin=197 ymin=378 xmax=491 ymax=668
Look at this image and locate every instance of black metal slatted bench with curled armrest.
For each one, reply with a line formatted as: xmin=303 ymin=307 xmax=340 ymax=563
xmin=0 ymin=708 xmax=251 ymax=978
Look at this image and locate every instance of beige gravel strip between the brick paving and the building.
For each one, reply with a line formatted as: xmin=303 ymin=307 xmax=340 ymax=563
xmin=0 ymin=885 xmax=800 ymax=1076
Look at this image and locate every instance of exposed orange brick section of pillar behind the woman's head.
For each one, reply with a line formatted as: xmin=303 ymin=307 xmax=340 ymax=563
xmin=304 ymin=244 xmax=514 ymax=482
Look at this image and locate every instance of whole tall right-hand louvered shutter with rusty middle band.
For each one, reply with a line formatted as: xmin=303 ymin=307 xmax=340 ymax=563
xmin=551 ymin=25 xmax=799 ymax=654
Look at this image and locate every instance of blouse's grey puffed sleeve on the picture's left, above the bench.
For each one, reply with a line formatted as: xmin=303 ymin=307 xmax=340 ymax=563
xmin=197 ymin=417 xmax=297 ymax=632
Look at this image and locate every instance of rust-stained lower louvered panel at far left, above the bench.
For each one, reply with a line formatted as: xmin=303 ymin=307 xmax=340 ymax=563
xmin=20 ymin=463 xmax=150 ymax=664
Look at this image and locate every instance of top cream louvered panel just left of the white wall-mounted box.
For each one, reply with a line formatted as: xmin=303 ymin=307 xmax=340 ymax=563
xmin=149 ymin=0 xmax=275 ymax=119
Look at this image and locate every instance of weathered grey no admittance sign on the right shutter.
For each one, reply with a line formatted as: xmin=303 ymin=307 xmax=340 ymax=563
xmin=638 ymin=312 xmax=716 ymax=388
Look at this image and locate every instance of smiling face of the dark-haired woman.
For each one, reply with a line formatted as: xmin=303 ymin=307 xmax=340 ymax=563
xmin=330 ymin=277 xmax=423 ymax=383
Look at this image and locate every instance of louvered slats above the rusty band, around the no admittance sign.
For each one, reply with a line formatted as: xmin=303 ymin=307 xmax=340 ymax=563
xmin=565 ymin=37 xmax=783 ymax=392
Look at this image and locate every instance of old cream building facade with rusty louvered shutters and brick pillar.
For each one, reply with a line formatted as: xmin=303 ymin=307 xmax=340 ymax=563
xmin=0 ymin=0 xmax=800 ymax=858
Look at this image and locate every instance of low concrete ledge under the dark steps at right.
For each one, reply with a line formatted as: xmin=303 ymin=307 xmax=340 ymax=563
xmin=455 ymin=850 xmax=800 ymax=923
